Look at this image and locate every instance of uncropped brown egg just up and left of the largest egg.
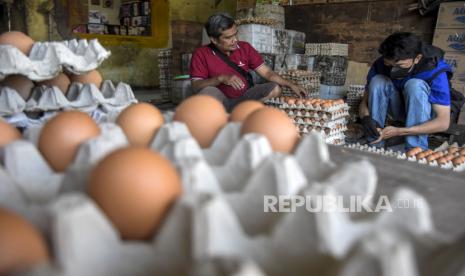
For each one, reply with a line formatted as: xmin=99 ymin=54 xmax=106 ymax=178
xmin=38 ymin=110 xmax=100 ymax=172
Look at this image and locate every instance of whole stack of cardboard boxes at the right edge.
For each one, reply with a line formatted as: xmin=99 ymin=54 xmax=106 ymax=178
xmin=433 ymin=1 xmax=465 ymax=94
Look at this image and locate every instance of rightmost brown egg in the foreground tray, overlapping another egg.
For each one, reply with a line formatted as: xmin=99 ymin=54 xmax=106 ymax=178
xmin=241 ymin=107 xmax=299 ymax=153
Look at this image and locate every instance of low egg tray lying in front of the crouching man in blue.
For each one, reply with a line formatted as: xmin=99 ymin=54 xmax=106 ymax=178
xmin=347 ymin=143 xmax=465 ymax=172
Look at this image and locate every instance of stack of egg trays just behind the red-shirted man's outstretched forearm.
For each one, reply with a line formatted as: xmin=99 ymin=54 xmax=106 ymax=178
xmin=279 ymin=70 xmax=321 ymax=98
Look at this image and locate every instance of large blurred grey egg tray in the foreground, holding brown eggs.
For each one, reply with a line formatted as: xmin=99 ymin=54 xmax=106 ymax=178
xmin=0 ymin=118 xmax=438 ymax=276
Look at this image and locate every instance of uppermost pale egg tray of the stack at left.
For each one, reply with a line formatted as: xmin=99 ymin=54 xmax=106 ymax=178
xmin=0 ymin=39 xmax=111 ymax=81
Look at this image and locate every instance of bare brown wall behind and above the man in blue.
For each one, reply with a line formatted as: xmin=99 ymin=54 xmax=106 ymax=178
xmin=286 ymin=0 xmax=437 ymax=63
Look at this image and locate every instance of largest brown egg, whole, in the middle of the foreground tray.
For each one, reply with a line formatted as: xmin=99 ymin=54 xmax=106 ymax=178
xmin=87 ymin=147 xmax=182 ymax=240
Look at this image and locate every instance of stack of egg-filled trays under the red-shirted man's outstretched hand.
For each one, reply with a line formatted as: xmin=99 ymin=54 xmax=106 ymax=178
xmin=269 ymin=97 xmax=349 ymax=145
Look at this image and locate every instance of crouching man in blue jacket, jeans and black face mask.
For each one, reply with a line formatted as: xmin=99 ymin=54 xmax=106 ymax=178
xmin=360 ymin=33 xmax=452 ymax=150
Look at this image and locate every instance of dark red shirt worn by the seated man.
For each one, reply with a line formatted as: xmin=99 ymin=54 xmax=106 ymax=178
xmin=190 ymin=41 xmax=264 ymax=98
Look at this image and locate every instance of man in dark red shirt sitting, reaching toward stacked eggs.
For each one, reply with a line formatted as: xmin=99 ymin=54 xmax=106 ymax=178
xmin=190 ymin=13 xmax=306 ymax=111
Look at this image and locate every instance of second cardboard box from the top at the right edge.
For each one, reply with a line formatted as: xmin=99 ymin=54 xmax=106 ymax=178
xmin=433 ymin=29 xmax=465 ymax=53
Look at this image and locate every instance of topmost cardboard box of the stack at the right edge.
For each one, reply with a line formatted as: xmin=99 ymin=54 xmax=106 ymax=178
xmin=436 ymin=1 xmax=465 ymax=28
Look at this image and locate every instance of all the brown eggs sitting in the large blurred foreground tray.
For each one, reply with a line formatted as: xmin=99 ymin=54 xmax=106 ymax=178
xmin=0 ymin=96 xmax=299 ymax=274
